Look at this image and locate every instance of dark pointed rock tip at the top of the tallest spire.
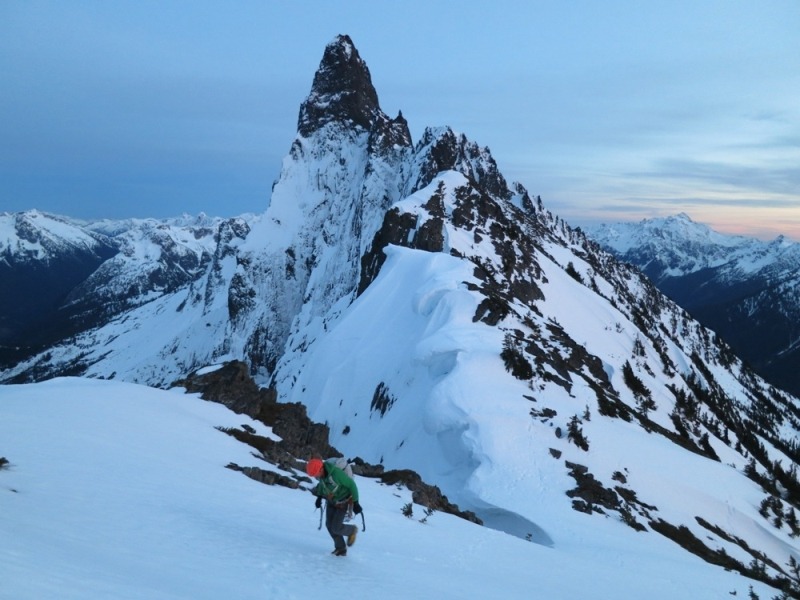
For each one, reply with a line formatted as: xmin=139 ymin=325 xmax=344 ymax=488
xmin=297 ymin=35 xmax=382 ymax=137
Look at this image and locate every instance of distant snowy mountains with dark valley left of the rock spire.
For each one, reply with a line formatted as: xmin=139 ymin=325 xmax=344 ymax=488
xmin=0 ymin=210 xmax=219 ymax=365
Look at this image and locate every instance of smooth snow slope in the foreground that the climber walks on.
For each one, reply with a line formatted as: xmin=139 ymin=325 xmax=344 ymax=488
xmin=0 ymin=379 xmax=774 ymax=600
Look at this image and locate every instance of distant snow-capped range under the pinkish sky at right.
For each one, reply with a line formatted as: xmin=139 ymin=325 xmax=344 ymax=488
xmin=587 ymin=214 xmax=800 ymax=395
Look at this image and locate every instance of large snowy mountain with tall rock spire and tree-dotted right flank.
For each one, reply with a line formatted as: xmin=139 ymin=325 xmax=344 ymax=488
xmin=0 ymin=36 xmax=800 ymax=597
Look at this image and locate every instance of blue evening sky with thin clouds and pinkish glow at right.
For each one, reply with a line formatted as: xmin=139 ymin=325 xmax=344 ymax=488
xmin=0 ymin=0 xmax=800 ymax=241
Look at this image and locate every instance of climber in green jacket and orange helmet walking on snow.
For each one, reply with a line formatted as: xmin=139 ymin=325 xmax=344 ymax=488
xmin=306 ymin=458 xmax=361 ymax=556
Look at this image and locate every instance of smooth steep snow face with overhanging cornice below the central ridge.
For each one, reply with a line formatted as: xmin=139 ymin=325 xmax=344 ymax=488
xmin=287 ymin=243 xmax=502 ymax=488
